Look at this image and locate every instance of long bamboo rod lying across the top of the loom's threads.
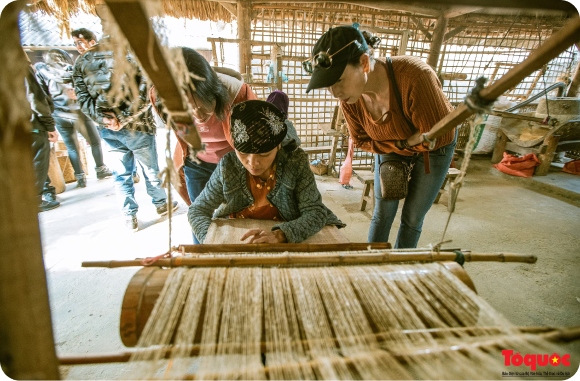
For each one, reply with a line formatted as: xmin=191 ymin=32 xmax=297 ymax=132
xmin=82 ymin=251 xmax=537 ymax=268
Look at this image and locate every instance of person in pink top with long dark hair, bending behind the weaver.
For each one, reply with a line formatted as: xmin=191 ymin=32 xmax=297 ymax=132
xmin=173 ymin=48 xmax=258 ymax=244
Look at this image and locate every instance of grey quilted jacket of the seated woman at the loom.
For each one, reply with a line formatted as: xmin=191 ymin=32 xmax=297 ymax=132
xmin=187 ymin=148 xmax=346 ymax=243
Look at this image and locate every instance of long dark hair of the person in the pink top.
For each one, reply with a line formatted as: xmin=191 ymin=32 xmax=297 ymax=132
xmin=181 ymin=47 xmax=230 ymax=120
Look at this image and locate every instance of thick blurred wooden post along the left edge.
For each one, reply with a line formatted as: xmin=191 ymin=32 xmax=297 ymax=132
xmin=0 ymin=0 xmax=59 ymax=381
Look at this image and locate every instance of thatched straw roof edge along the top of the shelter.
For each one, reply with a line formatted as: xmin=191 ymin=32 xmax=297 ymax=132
xmin=26 ymin=0 xmax=569 ymax=47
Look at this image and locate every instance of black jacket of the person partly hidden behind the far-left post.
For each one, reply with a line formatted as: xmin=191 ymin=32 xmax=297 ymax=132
xmin=24 ymin=66 xmax=55 ymax=132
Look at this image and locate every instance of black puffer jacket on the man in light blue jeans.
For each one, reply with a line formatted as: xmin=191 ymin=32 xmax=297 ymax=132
xmin=73 ymin=39 xmax=155 ymax=133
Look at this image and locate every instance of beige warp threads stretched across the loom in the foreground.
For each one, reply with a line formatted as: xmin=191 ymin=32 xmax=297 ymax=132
xmin=116 ymin=264 xmax=558 ymax=381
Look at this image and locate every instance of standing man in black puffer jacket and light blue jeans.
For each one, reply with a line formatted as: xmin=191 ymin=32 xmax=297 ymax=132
xmin=72 ymin=30 xmax=177 ymax=231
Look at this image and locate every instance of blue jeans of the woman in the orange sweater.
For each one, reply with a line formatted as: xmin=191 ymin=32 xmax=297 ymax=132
xmin=368 ymin=135 xmax=457 ymax=249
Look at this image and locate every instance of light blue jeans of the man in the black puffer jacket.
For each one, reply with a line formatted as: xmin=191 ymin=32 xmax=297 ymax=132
xmin=101 ymin=128 xmax=167 ymax=216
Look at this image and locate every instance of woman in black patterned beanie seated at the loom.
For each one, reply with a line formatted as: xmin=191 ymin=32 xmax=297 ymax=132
xmin=188 ymin=101 xmax=345 ymax=243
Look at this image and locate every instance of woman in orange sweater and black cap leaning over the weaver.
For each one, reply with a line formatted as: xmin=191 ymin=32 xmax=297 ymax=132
xmin=304 ymin=26 xmax=456 ymax=248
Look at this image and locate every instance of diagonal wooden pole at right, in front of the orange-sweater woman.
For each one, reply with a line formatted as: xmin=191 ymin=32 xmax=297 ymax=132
xmin=408 ymin=15 xmax=580 ymax=146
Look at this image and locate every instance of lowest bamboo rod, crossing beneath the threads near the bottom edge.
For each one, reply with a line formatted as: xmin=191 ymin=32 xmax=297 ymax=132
xmin=58 ymin=327 xmax=580 ymax=365
